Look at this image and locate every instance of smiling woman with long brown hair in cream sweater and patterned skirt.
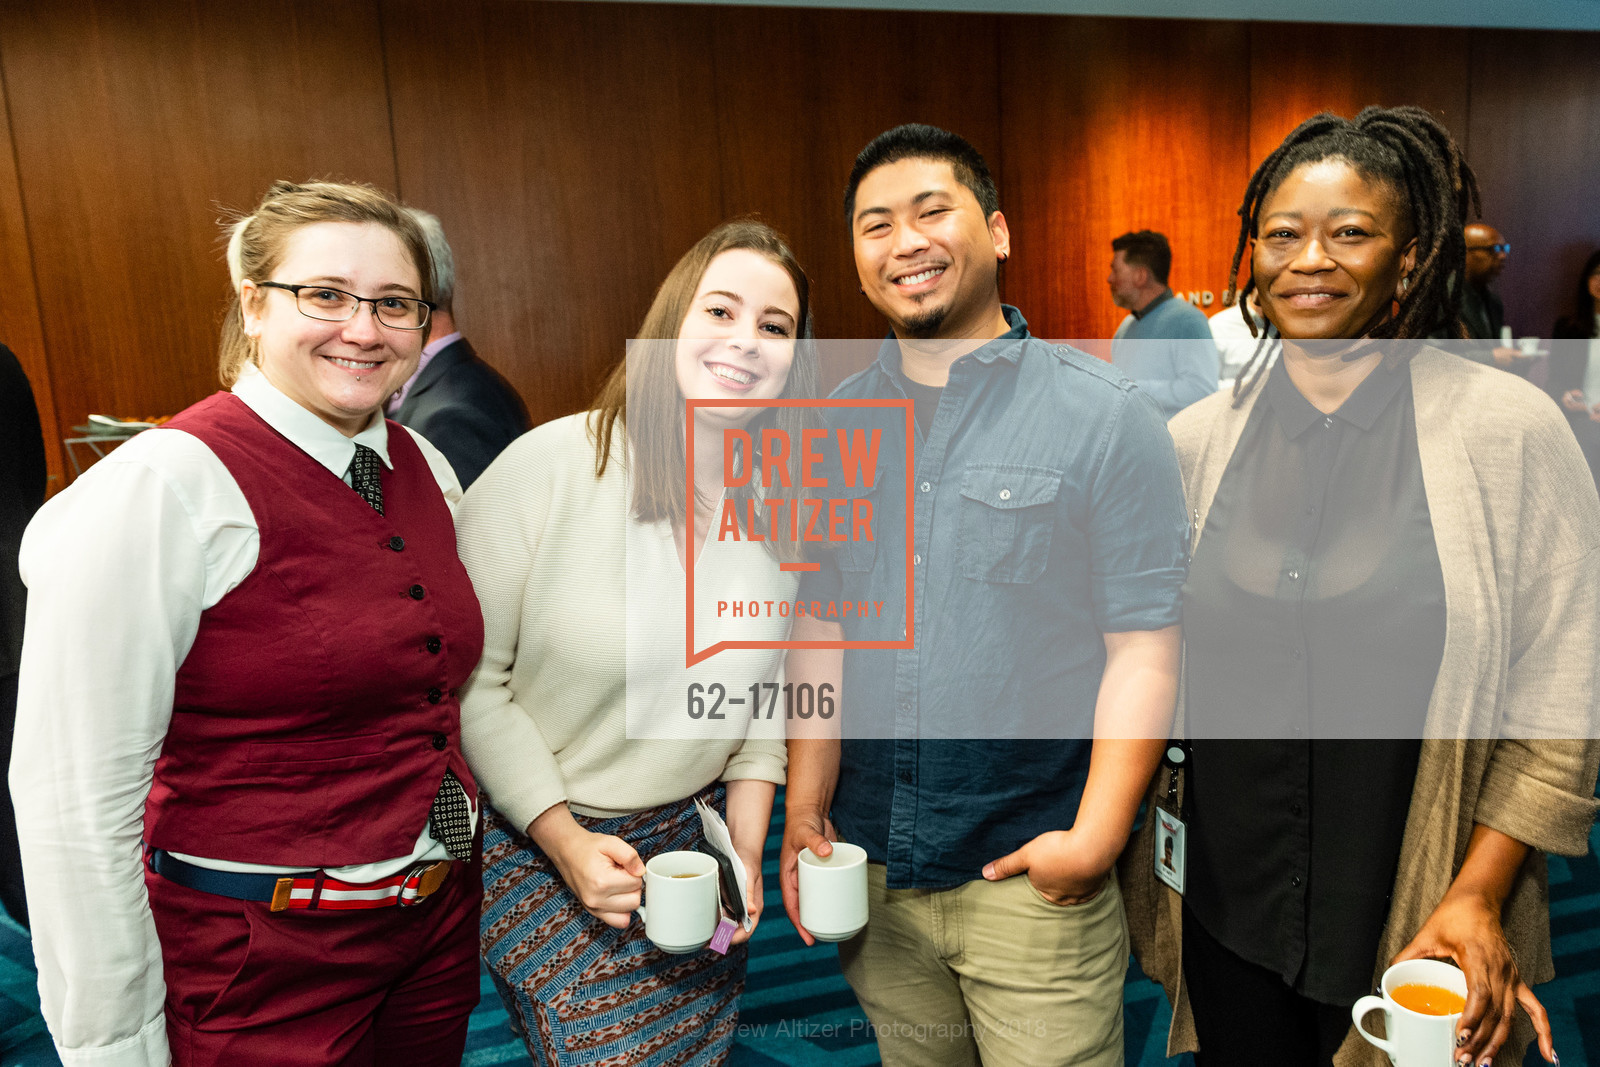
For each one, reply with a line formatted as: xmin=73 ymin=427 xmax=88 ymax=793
xmin=461 ymin=221 xmax=818 ymax=1067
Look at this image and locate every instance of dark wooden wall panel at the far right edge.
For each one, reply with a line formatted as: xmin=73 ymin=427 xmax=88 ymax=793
xmin=1467 ymin=30 xmax=1600 ymax=336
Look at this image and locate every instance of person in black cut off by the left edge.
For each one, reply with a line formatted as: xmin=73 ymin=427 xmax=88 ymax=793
xmin=0 ymin=344 xmax=45 ymax=926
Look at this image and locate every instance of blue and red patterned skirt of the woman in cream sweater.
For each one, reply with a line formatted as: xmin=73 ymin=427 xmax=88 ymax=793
xmin=482 ymin=785 xmax=746 ymax=1067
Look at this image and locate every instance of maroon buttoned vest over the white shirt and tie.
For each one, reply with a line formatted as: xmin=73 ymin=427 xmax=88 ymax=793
xmin=144 ymin=394 xmax=483 ymax=867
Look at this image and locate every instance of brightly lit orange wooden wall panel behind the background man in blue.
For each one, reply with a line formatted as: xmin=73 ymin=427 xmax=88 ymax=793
xmin=1000 ymin=18 xmax=1250 ymax=339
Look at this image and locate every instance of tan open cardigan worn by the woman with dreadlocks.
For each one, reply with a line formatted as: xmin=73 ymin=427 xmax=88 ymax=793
xmin=1122 ymin=349 xmax=1600 ymax=1067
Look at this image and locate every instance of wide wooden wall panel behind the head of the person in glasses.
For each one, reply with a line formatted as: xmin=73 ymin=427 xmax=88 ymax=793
xmin=0 ymin=0 xmax=395 ymax=470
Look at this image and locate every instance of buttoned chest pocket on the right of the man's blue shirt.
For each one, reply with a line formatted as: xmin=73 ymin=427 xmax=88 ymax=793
xmin=955 ymin=464 xmax=1062 ymax=584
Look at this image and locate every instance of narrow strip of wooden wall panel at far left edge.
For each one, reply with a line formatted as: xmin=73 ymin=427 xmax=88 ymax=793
xmin=0 ymin=60 xmax=64 ymax=493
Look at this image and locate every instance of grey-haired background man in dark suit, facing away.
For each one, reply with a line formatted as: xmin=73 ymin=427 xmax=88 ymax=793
xmin=387 ymin=208 xmax=530 ymax=488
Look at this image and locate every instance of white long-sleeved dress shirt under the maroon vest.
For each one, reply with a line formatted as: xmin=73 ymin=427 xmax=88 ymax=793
xmin=11 ymin=371 xmax=461 ymax=1067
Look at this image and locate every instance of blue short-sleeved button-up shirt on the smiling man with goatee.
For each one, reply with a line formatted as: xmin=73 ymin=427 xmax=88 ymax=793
xmin=800 ymin=306 xmax=1189 ymax=888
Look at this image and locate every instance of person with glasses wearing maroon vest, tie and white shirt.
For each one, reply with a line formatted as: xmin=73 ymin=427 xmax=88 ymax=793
xmin=11 ymin=182 xmax=483 ymax=1067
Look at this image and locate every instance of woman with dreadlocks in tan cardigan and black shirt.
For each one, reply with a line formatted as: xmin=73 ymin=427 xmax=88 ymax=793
xmin=1123 ymin=109 xmax=1600 ymax=1067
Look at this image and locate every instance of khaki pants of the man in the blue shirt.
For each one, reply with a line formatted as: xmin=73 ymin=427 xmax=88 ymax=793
xmin=838 ymin=864 xmax=1128 ymax=1067
